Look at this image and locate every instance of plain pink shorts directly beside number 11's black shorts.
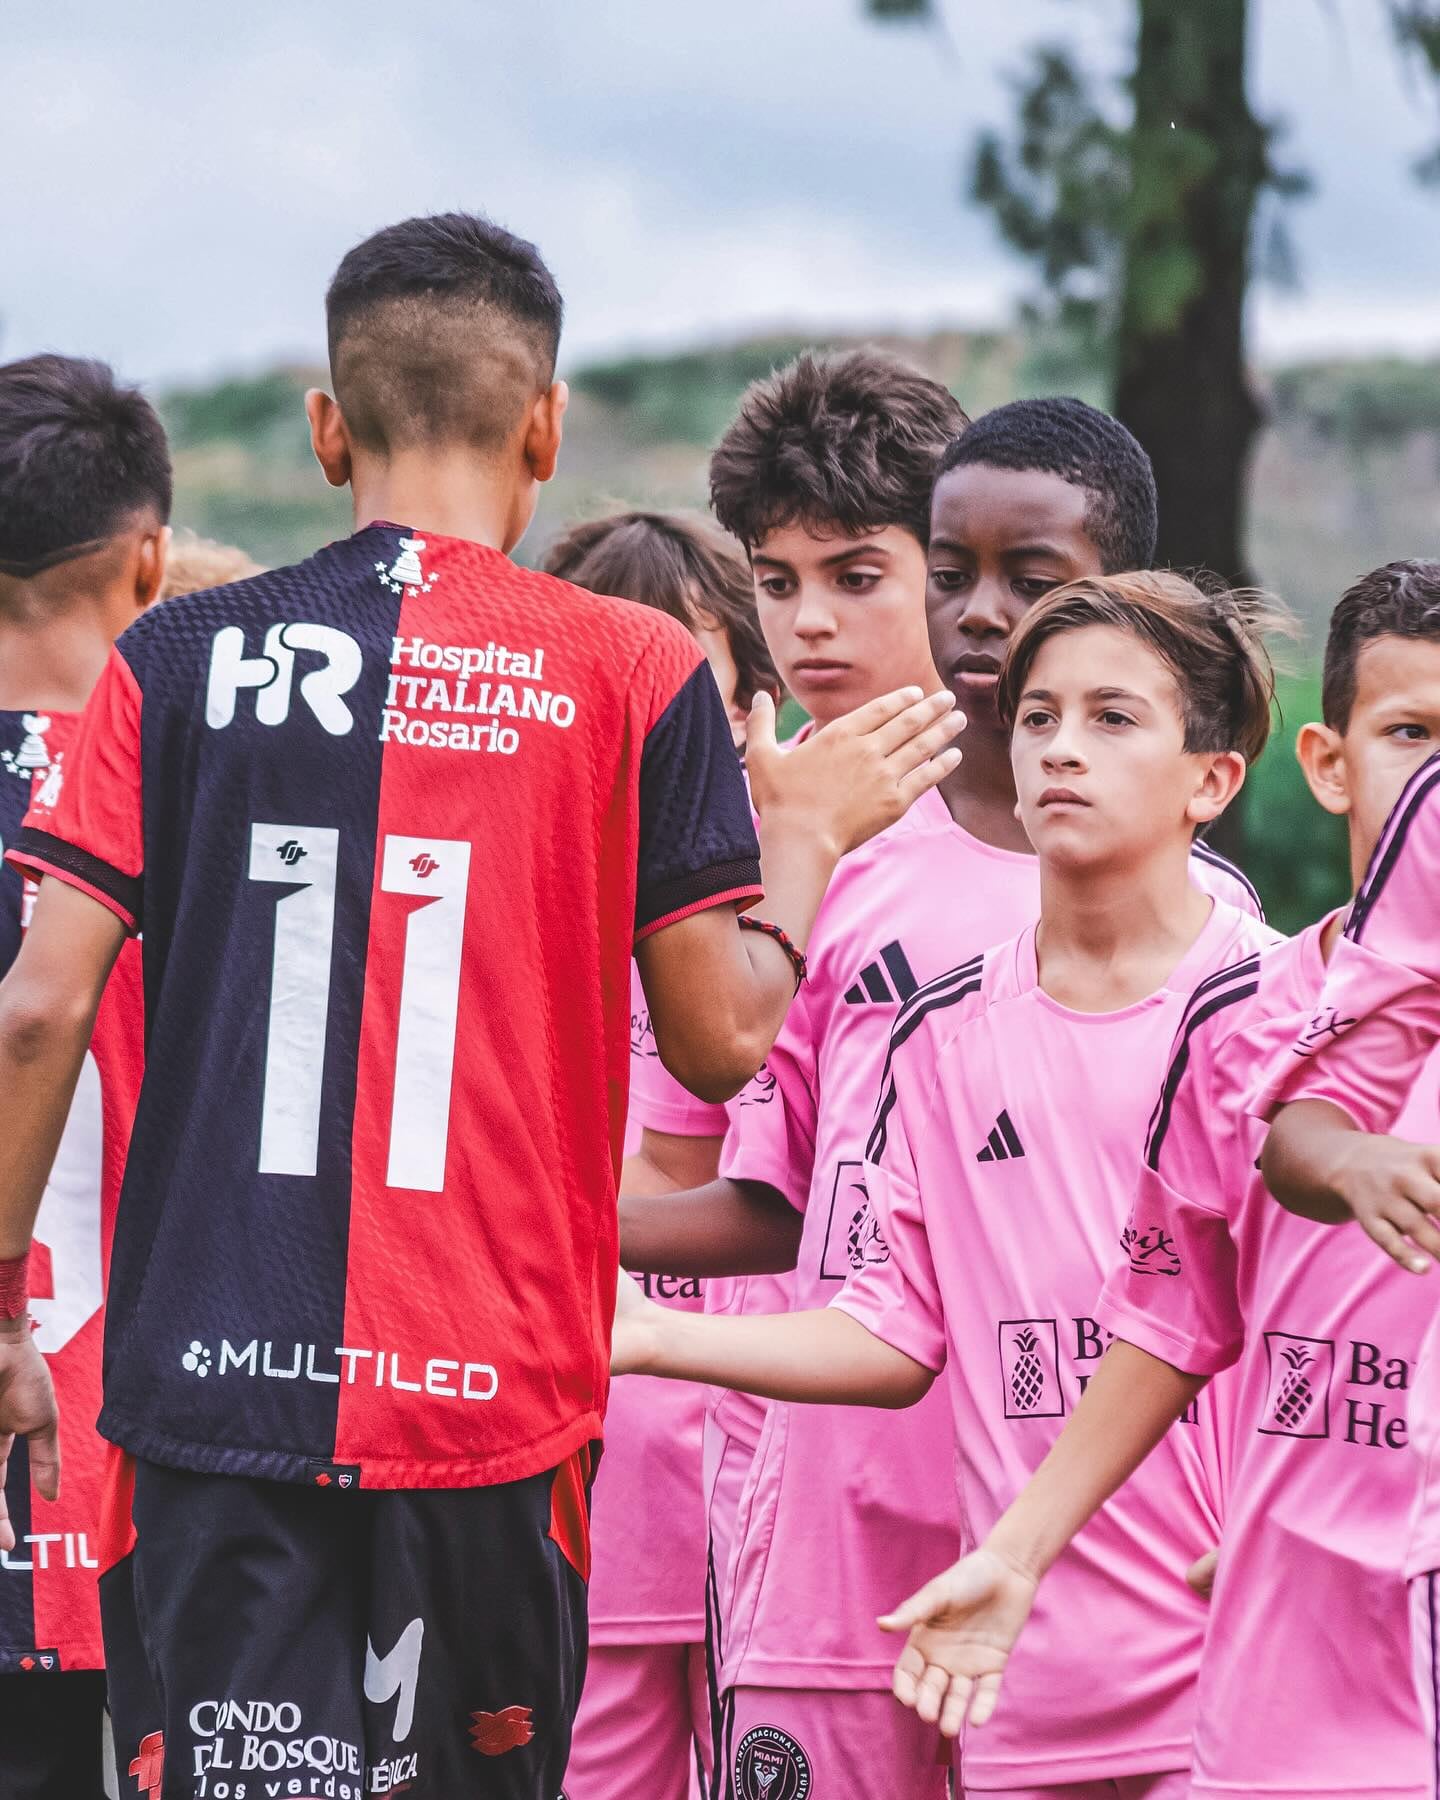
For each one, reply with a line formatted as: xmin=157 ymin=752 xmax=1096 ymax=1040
xmin=565 ymin=1643 xmax=711 ymax=1800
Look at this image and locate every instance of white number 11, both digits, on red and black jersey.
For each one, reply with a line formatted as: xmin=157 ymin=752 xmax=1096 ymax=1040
xmin=250 ymin=824 xmax=470 ymax=1193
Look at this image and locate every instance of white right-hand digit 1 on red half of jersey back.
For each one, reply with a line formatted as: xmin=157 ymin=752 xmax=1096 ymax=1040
xmin=380 ymin=837 xmax=470 ymax=1193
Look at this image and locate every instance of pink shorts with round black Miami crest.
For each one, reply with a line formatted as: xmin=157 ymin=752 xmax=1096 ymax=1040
xmin=716 ymin=1687 xmax=949 ymax=1800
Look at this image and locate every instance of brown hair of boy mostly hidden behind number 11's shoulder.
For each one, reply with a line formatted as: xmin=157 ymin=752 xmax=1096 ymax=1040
xmin=542 ymin=513 xmax=779 ymax=711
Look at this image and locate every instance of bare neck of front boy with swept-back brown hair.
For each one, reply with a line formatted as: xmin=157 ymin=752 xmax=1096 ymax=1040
xmin=1035 ymin=842 xmax=1215 ymax=1013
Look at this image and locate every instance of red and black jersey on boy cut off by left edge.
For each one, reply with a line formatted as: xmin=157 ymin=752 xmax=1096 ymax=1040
xmin=0 ymin=711 xmax=144 ymax=1674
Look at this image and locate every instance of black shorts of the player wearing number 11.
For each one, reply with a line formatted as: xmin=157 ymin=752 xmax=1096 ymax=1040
xmin=101 ymin=1453 xmax=589 ymax=1800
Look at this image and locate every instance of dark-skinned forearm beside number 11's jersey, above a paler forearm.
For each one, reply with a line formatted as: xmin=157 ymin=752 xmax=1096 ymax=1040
xmin=619 ymin=1181 xmax=801 ymax=1276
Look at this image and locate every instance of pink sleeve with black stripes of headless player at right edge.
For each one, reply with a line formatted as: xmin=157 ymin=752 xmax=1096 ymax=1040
xmin=1249 ymin=756 xmax=1440 ymax=1130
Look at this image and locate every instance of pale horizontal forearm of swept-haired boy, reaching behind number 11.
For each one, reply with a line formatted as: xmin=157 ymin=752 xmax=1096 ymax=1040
xmin=635 ymin=1307 xmax=934 ymax=1406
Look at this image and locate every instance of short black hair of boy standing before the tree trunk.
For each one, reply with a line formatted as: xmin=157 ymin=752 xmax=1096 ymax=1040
xmin=938 ymin=398 xmax=1159 ymax=574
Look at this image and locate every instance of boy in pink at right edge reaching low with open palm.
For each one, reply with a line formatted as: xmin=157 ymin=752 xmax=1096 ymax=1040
xmin=871 ymin=563 xmax=1440 ymax=1800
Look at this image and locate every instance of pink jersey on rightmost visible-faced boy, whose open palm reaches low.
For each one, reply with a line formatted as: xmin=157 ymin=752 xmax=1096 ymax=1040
xmin=1100 ymin=927 xmax=1440 ymax=1800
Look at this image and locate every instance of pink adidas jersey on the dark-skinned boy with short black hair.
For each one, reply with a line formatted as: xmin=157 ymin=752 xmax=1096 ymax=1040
xmin=722 ymin=794 xmax=1040 ymax=1688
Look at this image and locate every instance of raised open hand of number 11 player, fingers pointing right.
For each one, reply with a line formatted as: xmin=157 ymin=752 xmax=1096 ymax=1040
xmin=745 ymin=688 xmax=965 ymax=857
